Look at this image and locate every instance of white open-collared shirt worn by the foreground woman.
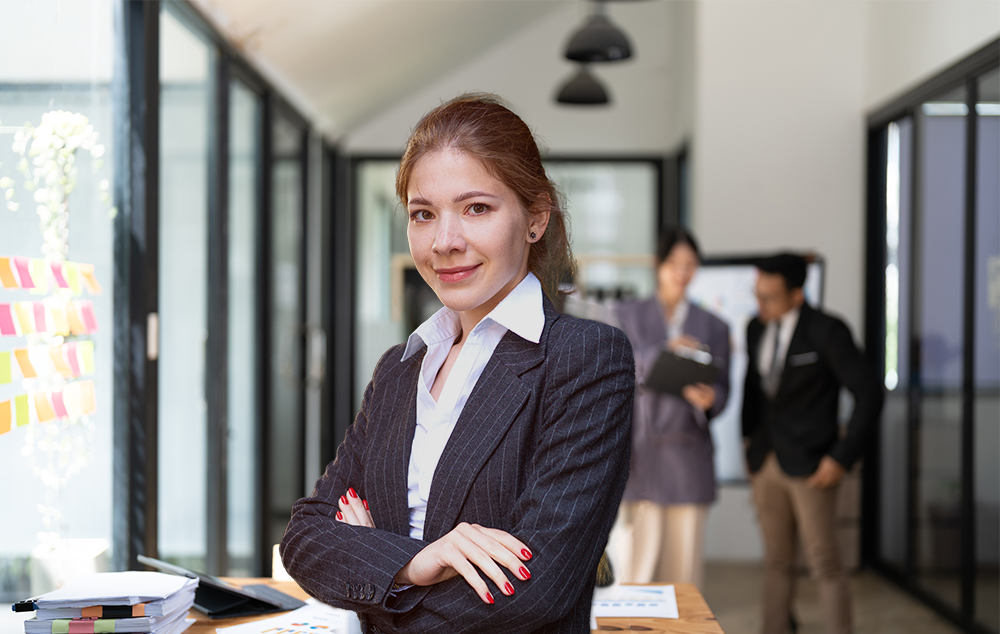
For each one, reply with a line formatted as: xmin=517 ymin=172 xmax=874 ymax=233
xmin=402 ymin=273 xmax=545 ymax=539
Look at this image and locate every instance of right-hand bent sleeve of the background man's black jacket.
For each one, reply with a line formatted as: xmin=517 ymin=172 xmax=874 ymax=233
xmin=818 ymin=319 xmax=884 ymax=469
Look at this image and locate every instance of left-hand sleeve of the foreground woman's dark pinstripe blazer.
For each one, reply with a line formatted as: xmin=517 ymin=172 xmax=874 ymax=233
xmin=279 ymin=351 xmax=427 ymax=613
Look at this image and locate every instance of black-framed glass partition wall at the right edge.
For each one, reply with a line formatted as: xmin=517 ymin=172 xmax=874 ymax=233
xmin=866 ymin=38 xmax=1000 ymax=632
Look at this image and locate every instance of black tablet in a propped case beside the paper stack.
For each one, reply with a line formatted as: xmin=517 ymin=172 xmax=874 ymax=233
xmin=136 ymin=555 xmax=305 ymax=619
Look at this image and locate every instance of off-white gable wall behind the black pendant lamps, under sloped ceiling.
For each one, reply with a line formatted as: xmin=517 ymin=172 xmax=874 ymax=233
xmin=343 ymin=0 xmax=694 ymax=155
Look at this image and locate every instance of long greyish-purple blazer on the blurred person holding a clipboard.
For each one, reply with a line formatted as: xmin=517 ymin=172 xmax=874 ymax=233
xmin=618 ymin=297 xmax=730 ymax=504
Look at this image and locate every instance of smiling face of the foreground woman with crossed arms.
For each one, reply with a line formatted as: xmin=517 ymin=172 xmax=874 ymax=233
xmin=406 ymin=150 xmax=548 ymax=328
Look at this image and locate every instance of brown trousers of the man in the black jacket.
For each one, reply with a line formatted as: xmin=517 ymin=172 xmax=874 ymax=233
xmin=751 ymin=452 xmax=852 ymax=634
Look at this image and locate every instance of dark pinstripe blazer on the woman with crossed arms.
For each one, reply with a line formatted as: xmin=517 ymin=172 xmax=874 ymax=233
xmin=281 ymin=299 xmax=635 ymax=634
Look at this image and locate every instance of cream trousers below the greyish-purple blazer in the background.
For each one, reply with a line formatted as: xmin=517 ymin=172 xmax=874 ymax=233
xmin=622 ymin=501 xmax=708 ymax=588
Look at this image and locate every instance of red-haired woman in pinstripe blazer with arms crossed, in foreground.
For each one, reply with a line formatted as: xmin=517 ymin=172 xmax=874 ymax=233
xmin=281 ymin=95 xmax=635 ymax=632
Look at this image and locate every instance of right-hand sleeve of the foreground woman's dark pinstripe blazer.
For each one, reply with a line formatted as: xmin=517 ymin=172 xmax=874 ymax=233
xmin=373 ymin=320 xmax=635 ymax=634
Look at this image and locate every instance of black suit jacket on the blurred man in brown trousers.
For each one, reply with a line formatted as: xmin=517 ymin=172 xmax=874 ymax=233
xmin=743 ymin=304 xmax=883 ymax=476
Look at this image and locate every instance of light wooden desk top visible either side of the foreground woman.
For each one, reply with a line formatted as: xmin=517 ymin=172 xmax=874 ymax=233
xmin=185 ymin=579 xmax=723 ymax=634
